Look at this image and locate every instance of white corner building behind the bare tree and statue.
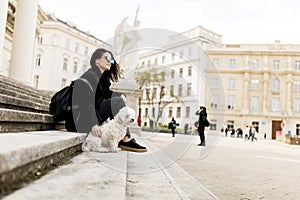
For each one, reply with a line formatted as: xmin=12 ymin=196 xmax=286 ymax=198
xmin=136 ymin=26 xmax=222 ymax=128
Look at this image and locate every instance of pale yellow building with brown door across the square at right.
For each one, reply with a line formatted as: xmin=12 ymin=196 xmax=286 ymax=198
xmin=205 ymin=41 xmax=300 ymax=139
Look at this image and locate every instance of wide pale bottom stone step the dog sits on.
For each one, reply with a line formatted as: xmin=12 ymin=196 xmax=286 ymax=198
xmin=3 ymin=132 xmax=218 ymax=200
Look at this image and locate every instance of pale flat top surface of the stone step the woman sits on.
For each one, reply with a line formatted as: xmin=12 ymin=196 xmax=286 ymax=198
xmin=0 ymin=131 xmax=85 ymax=174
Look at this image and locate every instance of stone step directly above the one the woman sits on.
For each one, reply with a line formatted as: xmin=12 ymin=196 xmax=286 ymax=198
xmin=0 ymin=108 xmax=64 ymax=133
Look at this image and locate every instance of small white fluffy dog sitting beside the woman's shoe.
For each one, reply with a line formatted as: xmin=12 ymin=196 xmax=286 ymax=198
xmin=82 ymin=106 xmax=135 ymax=153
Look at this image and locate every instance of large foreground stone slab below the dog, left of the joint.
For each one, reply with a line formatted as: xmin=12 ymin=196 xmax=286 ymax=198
xmin=3 ymin=152 xmax=127 ymax=200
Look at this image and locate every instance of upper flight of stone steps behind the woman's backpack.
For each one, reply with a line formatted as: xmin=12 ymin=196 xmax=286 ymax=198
xmin=0 ymin=75 xmax=63 ymax=133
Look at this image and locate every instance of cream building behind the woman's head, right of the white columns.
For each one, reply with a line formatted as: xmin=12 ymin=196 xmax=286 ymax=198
xmin=34 ymin=15 xmax=109 ymax=91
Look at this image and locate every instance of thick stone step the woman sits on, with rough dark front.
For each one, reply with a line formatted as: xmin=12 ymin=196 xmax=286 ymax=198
xmin=0 ymin=131 xmax=85 ymax=199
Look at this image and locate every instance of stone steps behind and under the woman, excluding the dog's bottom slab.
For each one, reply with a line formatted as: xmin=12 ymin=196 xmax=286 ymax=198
xmin=0 ymin=75 xmax=85 ymax=197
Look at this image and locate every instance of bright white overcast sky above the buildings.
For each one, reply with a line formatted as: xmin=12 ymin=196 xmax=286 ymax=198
xmin=39 ymin=0 xmax=300 ymax=44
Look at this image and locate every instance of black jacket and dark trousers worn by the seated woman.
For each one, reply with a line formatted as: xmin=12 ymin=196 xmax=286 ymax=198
xmin=65 ymin=67 xmax=126 ymax=134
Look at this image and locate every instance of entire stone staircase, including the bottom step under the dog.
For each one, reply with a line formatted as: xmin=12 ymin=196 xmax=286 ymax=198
xmin=0 ymin=76 xmax=217 ymax=200
